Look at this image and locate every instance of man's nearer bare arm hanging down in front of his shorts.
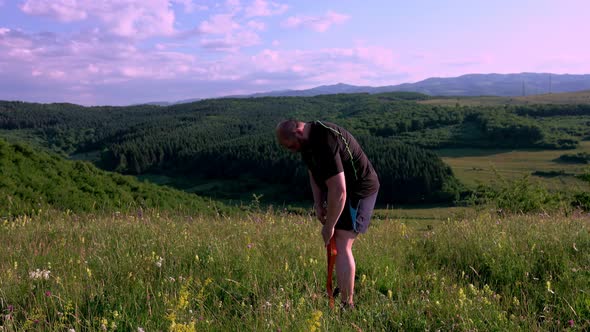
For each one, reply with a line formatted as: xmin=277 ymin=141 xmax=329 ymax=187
xmin=322 ymin=172 xmax=346 ymax=245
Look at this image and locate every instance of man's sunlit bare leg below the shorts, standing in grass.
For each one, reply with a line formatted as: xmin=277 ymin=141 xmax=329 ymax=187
xmin=334 ymin=229 xmax=357 ymax=304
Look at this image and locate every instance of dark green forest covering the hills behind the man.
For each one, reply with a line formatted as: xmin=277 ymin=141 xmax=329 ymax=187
xmin=0 ymin=93 xmax=590 ymax=204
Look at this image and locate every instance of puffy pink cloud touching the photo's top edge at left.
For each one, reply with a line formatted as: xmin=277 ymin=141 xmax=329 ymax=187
xmin=20 ymin=0 xmax=178 ymax=38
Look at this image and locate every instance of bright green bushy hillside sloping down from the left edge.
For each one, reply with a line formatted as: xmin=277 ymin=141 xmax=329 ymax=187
xmin=0 ymin=139 xmax=226 ymax=217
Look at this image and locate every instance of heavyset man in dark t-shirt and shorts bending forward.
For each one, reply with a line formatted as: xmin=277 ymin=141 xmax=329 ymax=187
xmin=276 ymin=120 xmax=379 ymax=308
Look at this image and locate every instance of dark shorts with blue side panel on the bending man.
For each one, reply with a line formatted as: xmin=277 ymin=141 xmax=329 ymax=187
xmin=335 ymin=193 xmax=377 ymax=234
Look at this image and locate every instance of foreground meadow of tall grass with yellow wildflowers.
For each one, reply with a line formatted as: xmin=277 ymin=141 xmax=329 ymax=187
xmin=0 ymin=210 xmax=590 ymax=331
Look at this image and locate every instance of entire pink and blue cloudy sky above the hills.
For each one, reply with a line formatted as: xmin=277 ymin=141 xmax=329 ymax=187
xmin=0 ymin=0 xmax=590 ymax=105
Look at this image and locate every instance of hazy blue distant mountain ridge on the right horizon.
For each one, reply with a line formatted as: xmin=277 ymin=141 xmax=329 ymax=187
xmin=221 ymin=73 xmax=590 ymax=98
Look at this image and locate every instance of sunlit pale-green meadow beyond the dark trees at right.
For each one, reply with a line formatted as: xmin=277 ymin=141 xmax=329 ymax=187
xmin=435 ymin=141 xmax=590 ymax=190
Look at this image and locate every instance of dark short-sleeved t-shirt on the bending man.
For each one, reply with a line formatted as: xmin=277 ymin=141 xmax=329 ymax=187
xmin=301 ymin=121 xmax=379 ymax=198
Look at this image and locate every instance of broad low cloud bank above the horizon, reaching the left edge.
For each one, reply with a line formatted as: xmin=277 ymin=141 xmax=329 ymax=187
xmin=0 ymin=24 xmax=414 ymax=105
